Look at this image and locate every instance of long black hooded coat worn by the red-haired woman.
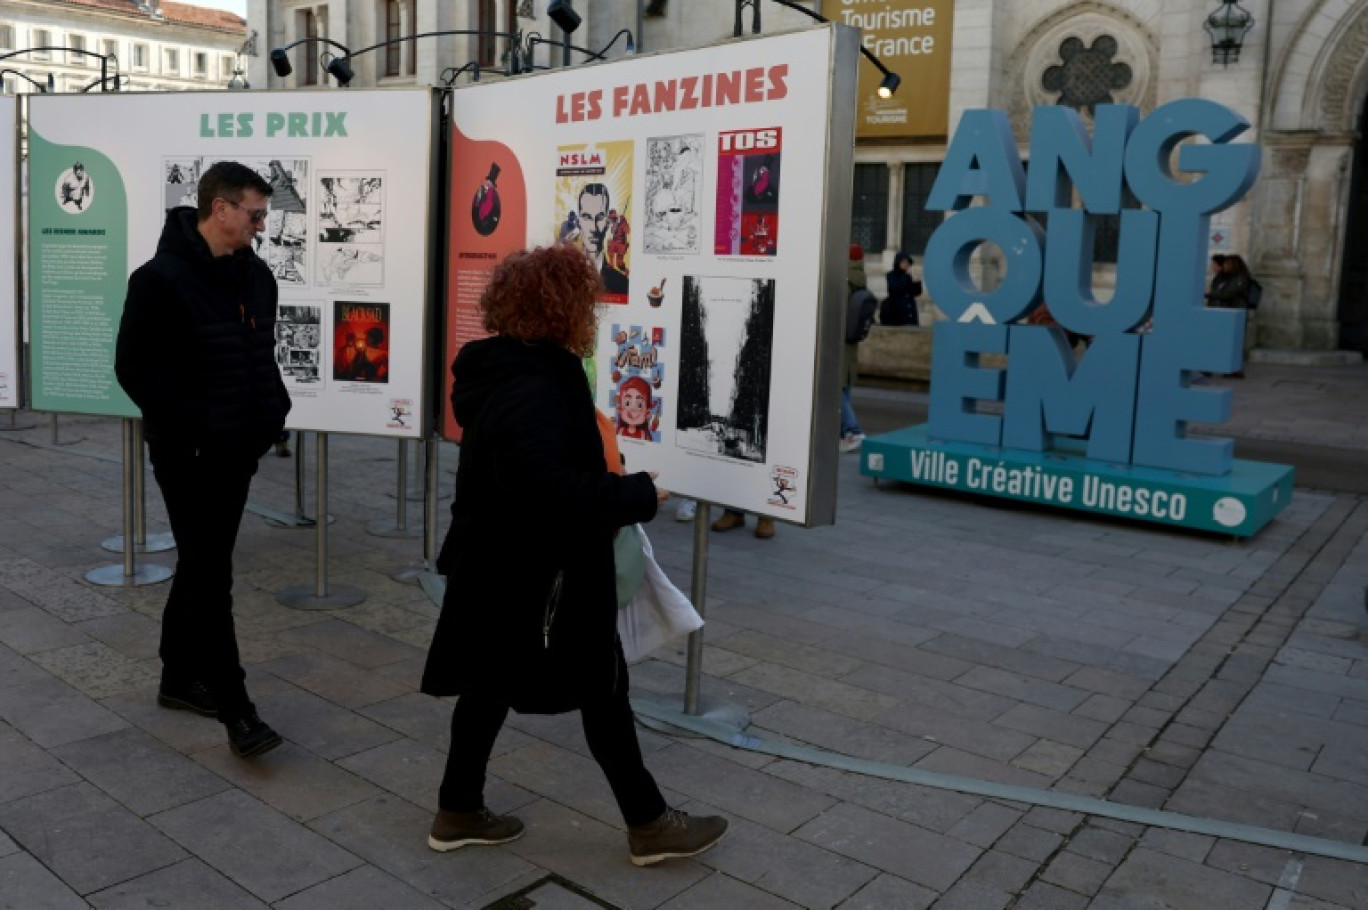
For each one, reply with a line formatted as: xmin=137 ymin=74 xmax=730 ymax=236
xmin=423 ymin=335 xmax=655 ymax=713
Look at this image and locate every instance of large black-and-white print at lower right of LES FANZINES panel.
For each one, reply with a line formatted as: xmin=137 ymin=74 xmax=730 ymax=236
xmin=674 ymin=275 xmax=774 ymax=463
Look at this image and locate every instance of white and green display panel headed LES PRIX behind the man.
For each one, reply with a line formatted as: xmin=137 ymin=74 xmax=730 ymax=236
xmin=30 ymin=89 xmax=434 ymax=438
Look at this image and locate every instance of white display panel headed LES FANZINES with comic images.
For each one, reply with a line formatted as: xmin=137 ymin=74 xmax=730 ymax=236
xmin=442 ymin=27 xmax=858 ymax=524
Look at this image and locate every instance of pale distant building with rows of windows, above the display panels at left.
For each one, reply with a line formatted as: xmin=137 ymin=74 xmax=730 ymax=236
xmin=0 ymin=0 xmax=248 ymax=93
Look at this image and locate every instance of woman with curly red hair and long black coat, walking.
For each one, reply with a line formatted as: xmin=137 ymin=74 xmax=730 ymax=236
xmin=421 ymin=246 xmax=726 ymax=866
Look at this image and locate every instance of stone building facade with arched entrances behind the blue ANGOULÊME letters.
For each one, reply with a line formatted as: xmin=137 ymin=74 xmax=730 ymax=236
xmin=240 ymin=0 xmax=1368 ymax=353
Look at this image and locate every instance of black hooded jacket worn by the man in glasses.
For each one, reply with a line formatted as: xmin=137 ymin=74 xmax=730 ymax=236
xmin=114 ymin=205 xmax=290 ymax=457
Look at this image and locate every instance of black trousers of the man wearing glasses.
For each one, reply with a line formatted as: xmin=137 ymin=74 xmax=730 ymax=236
xmin=148 ymin=442 xmax=257 ymax=721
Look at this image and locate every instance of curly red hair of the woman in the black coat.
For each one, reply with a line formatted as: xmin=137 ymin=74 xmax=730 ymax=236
xmin=480 ymin=246 xmax=603 ymax=356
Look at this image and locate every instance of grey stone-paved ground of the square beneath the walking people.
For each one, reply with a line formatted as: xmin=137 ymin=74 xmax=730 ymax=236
xmin=0 ymin=365 xmax=1368 ymax=910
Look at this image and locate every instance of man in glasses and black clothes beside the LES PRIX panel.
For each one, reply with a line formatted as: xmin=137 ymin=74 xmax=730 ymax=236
xmin=115 ymin=161 xmax=290 ymax=757
